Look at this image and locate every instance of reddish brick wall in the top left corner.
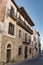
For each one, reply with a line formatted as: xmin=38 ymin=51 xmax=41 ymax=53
xmin=0 ymin=0 xmax=7 ymax=22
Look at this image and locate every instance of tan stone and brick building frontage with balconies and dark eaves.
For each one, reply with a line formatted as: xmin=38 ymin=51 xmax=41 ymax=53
xmin=0 ymin=0 xmax=39 ymax=62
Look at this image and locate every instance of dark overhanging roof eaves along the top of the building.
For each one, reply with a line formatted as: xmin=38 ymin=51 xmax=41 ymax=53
xmin=11 ymin=0 xmax=35 ymax=26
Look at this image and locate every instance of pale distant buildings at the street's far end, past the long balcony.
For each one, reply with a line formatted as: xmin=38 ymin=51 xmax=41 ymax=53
xmin=32 ymin=29 xmax=41 ymax=57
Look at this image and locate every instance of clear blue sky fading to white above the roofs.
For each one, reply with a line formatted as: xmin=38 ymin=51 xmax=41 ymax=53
xmin=15 ymin=0 xmax=43 ymax=49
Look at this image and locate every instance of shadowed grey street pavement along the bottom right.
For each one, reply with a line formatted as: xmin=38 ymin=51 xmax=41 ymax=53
xmin=8 ymin=56 xmax=43 ymax=65
